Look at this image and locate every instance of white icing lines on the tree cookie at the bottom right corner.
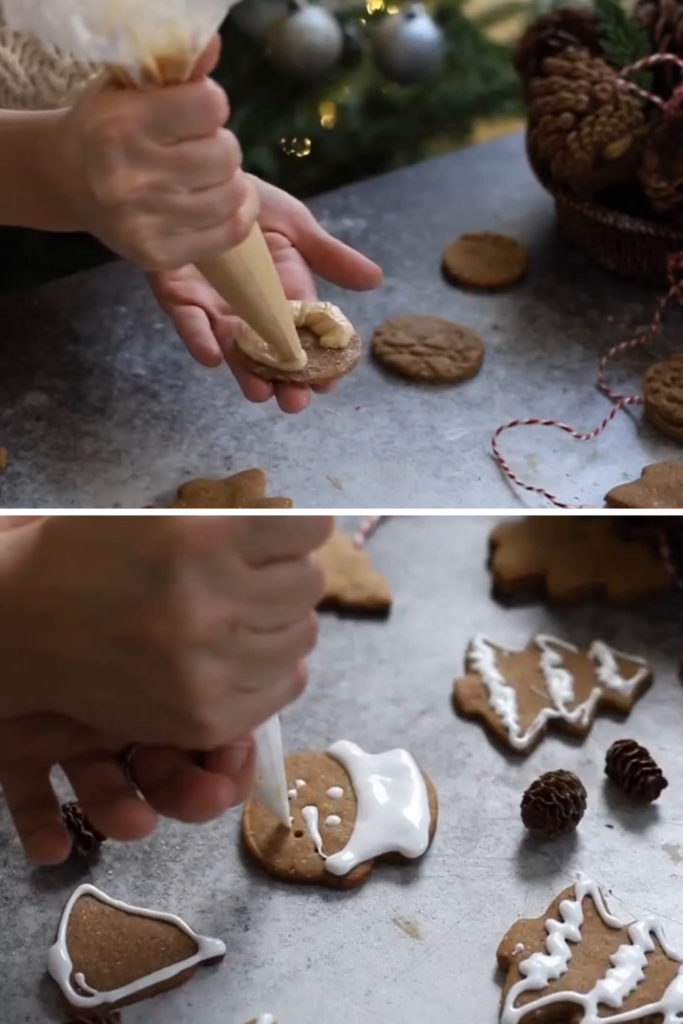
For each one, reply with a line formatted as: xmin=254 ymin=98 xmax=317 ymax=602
xmin=501 ymin=879 xmax=683 ymax=1024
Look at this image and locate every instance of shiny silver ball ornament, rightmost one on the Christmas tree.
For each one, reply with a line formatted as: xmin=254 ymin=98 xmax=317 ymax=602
xmin=373 ymin=4 xmax=445 ymax=85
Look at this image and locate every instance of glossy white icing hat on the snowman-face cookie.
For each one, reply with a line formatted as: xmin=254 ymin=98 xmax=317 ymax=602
xmin=326 ymin=739 xmax=431 ymax=876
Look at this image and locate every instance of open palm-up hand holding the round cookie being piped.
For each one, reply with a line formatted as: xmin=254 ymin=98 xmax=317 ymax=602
xmin=150 ymin=178 xmax=382 ymax=413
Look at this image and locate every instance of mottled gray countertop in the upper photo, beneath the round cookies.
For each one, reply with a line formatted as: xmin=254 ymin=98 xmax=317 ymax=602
xmin=0 ymin=136 xmax=681 ymax=509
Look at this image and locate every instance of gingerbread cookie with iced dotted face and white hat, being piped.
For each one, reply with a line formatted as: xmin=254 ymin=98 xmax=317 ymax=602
xmin=242 ymin=739 xmax=438 ymax=889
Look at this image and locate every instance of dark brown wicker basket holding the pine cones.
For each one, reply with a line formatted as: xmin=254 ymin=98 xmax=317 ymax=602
xmin=526 ymin=134 xmax=683 ymax=287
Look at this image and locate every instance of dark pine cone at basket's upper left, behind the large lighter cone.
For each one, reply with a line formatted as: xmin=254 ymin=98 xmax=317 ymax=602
xmin=512 ymin=7 xmax=600 ymax=85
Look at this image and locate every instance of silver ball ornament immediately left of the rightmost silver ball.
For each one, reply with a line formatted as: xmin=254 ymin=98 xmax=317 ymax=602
xmin=266 ymin=0 xmax=344 ymax=79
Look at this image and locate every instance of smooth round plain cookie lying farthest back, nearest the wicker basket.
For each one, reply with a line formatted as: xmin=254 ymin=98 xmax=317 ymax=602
xmin=443 ymin=231 xmax=528 ymax=291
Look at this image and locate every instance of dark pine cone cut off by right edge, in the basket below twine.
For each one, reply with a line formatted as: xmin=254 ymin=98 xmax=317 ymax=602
xmin=640 ymin=98 xmax=683 ymax=224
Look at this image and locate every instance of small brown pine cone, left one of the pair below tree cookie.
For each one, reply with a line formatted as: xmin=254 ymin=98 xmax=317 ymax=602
xmin=521 ymin=770 xmax=587 ymax=839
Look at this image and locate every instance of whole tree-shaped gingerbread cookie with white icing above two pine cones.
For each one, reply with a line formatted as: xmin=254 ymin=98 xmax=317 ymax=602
xmin=453 ymin=634 xmax=652 ymax=754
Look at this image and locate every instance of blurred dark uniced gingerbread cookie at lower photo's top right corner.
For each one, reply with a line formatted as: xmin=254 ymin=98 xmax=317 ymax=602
xmin=489 ymin=515 xmax=676 ymax=605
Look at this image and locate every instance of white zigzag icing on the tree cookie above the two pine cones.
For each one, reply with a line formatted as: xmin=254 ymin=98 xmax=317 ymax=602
xmin=467 ymin=634 xmax=649 ymax=751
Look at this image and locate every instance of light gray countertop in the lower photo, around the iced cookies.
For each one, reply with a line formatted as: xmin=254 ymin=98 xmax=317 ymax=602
xmin=0 ymin=517 xmax=683 ymax=1024
